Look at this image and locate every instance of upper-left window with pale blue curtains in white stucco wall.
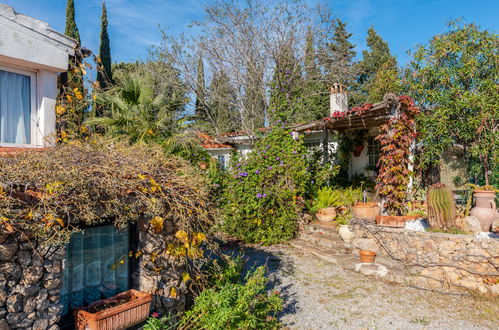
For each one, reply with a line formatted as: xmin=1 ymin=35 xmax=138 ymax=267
xmin=0 ymin=67 xmax=36 ymax=146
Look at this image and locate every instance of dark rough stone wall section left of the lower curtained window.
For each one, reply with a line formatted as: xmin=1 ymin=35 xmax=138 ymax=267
xmin=0 ymin=232 xmax=65 ymax=330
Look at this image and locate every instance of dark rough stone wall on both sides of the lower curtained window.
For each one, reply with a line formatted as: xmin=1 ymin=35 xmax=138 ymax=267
xmin=0 ymin=221 xmax=186 ymax=330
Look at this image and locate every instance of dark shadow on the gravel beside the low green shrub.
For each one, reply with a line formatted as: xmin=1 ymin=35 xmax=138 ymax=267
xmin=221 ymin=241 xmax=298 ymax=317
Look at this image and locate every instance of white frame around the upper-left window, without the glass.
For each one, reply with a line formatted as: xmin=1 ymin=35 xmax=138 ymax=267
xmin=0 ymin=62 xmax=38 ymax=148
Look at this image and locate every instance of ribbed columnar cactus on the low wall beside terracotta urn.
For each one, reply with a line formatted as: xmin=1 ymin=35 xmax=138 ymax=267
xmin=426 ymin=183 xmax=456 ymax=229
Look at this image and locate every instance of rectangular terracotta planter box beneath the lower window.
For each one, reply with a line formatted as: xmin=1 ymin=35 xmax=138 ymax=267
xmin=75 ymin=290 xmax=152 ymax=330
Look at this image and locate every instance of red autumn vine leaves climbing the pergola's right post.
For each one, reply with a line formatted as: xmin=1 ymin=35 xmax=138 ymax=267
xmin=376 ymin=95 xmax=419 ymax=215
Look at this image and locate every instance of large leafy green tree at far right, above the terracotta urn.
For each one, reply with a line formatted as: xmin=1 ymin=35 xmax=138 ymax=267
xmin=407 ymin=21 xmax=499 ymax=187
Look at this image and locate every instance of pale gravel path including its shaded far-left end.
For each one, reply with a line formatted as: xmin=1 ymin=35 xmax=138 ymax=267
xmin=234 ymin=245 xmax=499 ymax=330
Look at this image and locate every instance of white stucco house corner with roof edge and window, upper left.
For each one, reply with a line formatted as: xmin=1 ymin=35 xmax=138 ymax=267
xmin=0 ymin=3 xmax=76 ymax=149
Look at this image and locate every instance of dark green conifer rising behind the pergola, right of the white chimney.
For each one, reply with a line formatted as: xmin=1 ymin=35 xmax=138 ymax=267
xmin=357 ymin=26 xmax=399 ymax=103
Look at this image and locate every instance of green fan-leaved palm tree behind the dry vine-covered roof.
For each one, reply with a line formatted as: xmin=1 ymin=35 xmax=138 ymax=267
xmin=86 ymin=72 xmax=208 ymax=160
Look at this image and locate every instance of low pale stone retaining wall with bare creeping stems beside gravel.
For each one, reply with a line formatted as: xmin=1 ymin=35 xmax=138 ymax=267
xmin=352 ymin=223 xmax=499 ymax=295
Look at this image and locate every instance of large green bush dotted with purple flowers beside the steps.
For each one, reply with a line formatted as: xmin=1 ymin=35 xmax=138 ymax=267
xmin=222 ymin=128 xmax=308 ymax=244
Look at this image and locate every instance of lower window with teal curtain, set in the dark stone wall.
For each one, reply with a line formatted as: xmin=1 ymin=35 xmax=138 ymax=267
xmin=61 ymin=226 xmax=130 ymax=315
